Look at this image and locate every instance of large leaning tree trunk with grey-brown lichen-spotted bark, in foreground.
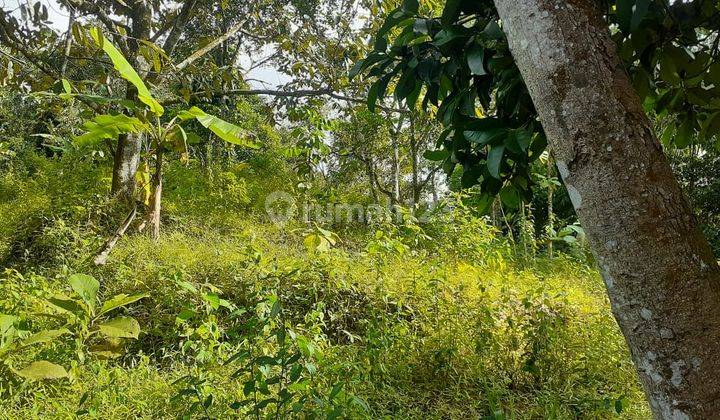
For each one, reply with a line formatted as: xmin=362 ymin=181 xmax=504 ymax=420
xmin=495 ymin=0 xmax=720 ymax=419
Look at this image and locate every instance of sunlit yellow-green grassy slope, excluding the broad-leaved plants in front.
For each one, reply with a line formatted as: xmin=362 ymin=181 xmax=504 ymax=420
xmin=0 ymin=156 xmax=649 ymax=418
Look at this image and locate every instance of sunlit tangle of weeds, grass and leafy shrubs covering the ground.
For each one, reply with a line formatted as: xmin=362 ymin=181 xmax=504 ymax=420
xmin=0 ymin=148 xmax=647 ymax=418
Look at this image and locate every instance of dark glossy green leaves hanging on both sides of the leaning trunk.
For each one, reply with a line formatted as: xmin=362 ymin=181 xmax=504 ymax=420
xmin=358 ymin=0 xmax=720 ymax=210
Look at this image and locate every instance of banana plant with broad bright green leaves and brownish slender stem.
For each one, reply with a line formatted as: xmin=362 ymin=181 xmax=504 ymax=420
xmin=60 ymin=28 xmax=258 ymax=239
